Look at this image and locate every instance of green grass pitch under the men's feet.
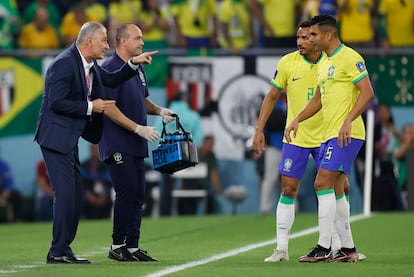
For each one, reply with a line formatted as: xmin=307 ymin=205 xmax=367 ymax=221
xmin=0 ymin=213 xmax=414 ymax=277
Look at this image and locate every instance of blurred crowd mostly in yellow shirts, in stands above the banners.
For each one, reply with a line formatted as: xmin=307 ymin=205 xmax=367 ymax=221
xmin=0 ymin=0 xmax=414 ymax=51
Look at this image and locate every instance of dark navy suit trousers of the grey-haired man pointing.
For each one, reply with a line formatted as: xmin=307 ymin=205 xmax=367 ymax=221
xmin=41 ymin=146 xmax=83 ymax=256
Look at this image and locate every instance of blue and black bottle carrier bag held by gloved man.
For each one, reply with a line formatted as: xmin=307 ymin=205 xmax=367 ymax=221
xmin=152 ymin=115 xmax=198 ymax=174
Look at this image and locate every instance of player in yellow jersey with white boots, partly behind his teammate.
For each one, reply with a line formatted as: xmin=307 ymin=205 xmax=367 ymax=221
xmin=253 ymin=21 xmax=325 ymax=262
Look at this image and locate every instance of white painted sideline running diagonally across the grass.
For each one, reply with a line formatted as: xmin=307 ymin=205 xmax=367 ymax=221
xmin=144 ymin=215 xmax=370 ymax=277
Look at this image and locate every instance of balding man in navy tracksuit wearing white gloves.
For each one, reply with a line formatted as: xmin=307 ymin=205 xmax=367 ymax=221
xmin=99 ymin=24 xmax=173 ymax=261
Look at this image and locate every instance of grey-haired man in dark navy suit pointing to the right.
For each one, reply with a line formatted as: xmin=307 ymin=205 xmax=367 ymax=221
xmin=35 ymin=22 xmax=159 ymax=264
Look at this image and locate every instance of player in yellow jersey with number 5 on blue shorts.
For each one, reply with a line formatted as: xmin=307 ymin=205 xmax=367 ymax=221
xmin=285 ymin=15 xmax=374 ymax=262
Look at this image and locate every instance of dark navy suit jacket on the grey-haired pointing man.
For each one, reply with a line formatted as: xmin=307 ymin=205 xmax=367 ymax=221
xmin=35 ymin=44 xmax=136 ymax=154
